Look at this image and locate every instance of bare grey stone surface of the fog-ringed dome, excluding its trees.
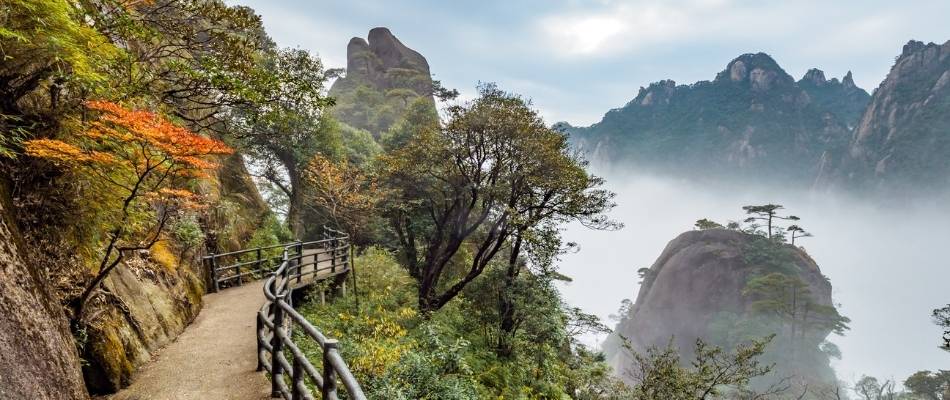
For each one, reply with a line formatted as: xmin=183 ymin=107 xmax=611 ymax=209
xmin=604 ymin=229 xmax=833 ymax=379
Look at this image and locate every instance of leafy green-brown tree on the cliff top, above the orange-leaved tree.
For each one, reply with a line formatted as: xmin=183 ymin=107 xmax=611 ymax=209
xmin=87 ymin=0 xmax=287 ymax=136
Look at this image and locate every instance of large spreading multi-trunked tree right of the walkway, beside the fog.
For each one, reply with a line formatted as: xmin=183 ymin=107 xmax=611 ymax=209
xmin=383 ymin=85 xmax=613 ymax=313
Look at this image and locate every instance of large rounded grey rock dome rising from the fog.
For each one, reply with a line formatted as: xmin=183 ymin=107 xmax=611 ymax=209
xmin=604 ymin=229 xmax=834 ymax=382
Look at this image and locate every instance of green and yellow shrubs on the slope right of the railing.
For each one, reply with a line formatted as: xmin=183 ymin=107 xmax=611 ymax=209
xmin=301 ymin=248 xmax=621 ymax=399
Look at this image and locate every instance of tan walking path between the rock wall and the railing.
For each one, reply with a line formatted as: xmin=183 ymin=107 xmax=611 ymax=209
xmin=108 ymin=281 xmax=270 ymax=400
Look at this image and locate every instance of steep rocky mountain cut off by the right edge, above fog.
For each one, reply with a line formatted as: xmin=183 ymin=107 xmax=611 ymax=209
xmin=818 ymin=41 xmax=950 ymax=192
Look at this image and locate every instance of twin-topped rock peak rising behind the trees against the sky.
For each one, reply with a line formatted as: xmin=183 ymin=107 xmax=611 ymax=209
xmin=330 ymin=28 xmax=432 ymax=137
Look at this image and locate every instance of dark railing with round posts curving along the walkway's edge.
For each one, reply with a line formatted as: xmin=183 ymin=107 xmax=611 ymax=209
xmin=204 ymin=229 xmax=366 ymax=400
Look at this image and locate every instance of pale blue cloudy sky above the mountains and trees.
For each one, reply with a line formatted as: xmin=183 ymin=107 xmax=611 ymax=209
xmin=229 ymin=0 xmax=950 ymax=125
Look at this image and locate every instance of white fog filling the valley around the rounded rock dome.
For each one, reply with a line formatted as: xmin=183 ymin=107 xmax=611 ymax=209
xmin=561 ymin=166 xmax=950 ymax=382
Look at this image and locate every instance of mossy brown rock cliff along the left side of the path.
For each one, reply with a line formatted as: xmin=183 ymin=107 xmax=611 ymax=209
xmin=0 ymin=150 xmax=269 ymax=399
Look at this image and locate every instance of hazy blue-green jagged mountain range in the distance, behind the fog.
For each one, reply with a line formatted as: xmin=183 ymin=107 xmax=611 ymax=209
xmin=559 ymin=53 xmax=870 ymax=183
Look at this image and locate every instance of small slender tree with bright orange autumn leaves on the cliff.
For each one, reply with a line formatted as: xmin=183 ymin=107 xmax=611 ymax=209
xmin=24 ymin=101 xmax=232 ymax=321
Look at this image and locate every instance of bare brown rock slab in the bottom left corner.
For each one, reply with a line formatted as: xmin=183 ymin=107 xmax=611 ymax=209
xmin=0 ymin=183 xmax=88 ymax=399
